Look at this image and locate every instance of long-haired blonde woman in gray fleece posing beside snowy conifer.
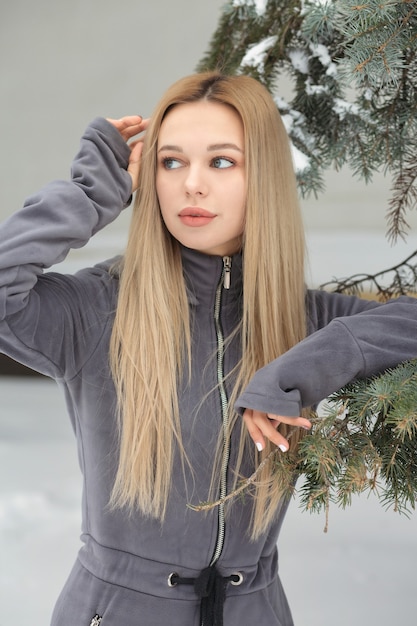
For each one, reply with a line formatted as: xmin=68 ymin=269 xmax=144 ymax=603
xmin=0 ymin=73 xmax=417 ymax=626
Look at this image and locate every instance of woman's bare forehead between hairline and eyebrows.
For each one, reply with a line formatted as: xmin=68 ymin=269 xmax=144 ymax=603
xmin=158 ymin=100 xmax=243 ymax=148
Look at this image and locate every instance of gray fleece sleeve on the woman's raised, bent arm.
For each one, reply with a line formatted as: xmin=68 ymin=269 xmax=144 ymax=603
xmin=0 ymin=118 xmax=132 ymax=376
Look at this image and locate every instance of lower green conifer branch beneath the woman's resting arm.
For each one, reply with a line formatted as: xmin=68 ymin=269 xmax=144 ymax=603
xmin=189 ymin=359 xmax=417 ymax=532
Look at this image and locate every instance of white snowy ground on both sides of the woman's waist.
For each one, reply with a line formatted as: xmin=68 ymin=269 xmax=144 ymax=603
xmin=0 ymin=377 xmax=417 ymax=626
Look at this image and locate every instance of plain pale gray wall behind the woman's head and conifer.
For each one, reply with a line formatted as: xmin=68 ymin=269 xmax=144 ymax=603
xmin=0 ymin=0 xmax=416 ymax=249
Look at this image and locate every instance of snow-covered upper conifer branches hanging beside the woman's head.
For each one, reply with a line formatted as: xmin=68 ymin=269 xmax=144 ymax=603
xmin=198 ymin=0 xmax=417 ymax=232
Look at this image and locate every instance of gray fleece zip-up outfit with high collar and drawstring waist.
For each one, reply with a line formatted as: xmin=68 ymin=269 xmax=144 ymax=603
xmin=0 ymin=119 xmax=417 ymax=626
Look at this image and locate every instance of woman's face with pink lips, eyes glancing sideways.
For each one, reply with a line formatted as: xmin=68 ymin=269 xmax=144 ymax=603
xmin=156 ymin=100 xmax=246 ymax=256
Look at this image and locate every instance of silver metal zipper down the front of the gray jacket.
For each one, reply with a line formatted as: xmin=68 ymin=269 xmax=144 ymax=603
xmin=210 ymin=256 xmax=232 ymax=565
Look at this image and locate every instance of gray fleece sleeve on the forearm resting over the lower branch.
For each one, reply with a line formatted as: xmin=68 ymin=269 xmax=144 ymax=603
xmin=235 ymin=297 xmax=417 ymax=416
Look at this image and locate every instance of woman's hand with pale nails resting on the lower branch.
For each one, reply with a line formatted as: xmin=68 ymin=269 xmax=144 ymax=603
xmin=243 ymin=409 xmax=311 ymax=452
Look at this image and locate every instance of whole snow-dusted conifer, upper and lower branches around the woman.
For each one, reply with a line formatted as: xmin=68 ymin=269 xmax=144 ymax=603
xmin=198 ymin=0 xmax=417 ymax=512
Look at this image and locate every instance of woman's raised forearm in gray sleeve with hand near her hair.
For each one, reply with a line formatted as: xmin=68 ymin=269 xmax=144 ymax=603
xmin=0 ymin=116 xmax=146 ymax=320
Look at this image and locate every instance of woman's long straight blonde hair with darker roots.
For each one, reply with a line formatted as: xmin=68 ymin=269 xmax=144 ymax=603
xmin=110 ymin=72 xmax=306 ymax=536
